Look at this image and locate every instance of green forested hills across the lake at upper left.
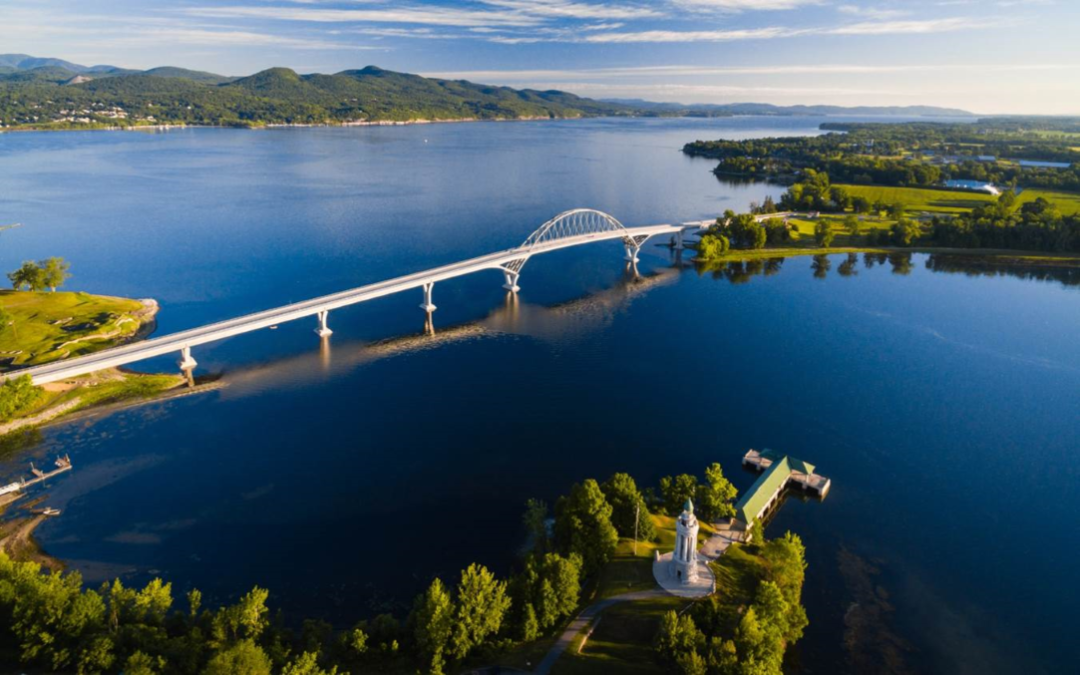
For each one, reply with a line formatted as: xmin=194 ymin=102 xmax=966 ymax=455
xmin=0 ymin=66 xmax=632 ymax=129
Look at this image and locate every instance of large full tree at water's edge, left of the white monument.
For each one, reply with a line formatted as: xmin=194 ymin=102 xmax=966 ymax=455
xmin=555 ymin=478 xmax=619 ymax=575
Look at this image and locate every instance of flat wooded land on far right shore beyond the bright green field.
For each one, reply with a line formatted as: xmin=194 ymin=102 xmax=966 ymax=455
xmin=684 ymin=118 xmax=1080 ymax=190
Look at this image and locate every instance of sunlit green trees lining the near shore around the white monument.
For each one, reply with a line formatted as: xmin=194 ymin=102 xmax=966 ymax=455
xmin=0 ymin=463 xmax=805 ymax=675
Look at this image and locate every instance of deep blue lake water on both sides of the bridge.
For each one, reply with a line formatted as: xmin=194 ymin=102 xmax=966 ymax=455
xmin=0 ymin=118 xmax=1080 ymax=673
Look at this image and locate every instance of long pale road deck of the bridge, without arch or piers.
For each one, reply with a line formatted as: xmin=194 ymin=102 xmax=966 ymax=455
xmin=4 ymin=221 xmax=699 ymax=384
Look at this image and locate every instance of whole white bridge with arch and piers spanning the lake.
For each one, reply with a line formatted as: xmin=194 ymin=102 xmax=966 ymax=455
xmin=12 ymin=208 xmax=715 ymax=384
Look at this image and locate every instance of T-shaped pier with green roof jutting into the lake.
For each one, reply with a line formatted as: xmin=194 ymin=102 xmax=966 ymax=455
xmin=735 ymin=449 xmax=833 ymax=532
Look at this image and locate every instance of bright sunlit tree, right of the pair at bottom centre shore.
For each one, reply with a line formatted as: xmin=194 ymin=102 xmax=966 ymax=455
xmin=448 ymin=563 xmax=510 ymax=660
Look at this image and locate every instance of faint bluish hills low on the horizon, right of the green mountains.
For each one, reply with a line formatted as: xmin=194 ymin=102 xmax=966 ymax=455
xmin=600 ymin=98 xmax=976 ymax=117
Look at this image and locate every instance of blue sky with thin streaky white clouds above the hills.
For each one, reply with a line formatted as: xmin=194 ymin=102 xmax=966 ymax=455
xmin=0 ymin=0 xmax=1080 ymax=114
